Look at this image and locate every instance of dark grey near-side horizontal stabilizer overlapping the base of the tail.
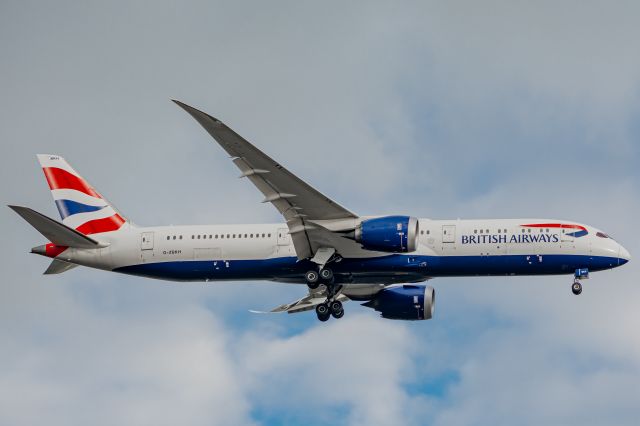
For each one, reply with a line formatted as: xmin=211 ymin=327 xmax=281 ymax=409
xmin=9 ymin=206 xmax=105 ymax=248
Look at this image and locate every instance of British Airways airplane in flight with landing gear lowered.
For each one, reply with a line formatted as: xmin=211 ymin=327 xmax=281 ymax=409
xmin=9 ymin=100 xmax=631 ymax=321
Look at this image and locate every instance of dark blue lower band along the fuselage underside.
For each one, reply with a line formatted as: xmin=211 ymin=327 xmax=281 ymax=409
xmin=114 ymin=254 xmax=619 ymax=283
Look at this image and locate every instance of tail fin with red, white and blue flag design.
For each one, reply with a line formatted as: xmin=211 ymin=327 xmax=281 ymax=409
xmin=38 ymin=154 xmax=127 ymax=235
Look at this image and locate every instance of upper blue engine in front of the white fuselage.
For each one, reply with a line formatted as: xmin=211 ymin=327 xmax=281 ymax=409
xmin=355 ymin=216 xmax=418 ymax=253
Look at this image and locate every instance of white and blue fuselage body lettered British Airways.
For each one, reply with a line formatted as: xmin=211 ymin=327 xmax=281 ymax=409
xmin=59 ymin=219 xmax=629 ymax=284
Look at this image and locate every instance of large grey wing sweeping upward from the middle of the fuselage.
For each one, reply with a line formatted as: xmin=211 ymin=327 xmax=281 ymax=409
xmin=174 ymin=100 xmax=358 ymax=259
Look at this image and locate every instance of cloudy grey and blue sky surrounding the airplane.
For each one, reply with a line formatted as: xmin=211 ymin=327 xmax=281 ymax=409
xmin=0 ymin=0 xmax=640 ymax=426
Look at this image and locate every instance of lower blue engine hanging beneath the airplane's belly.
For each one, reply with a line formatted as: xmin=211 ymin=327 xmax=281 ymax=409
xmin=362 ymin=284 xmax=436 ymax=320
